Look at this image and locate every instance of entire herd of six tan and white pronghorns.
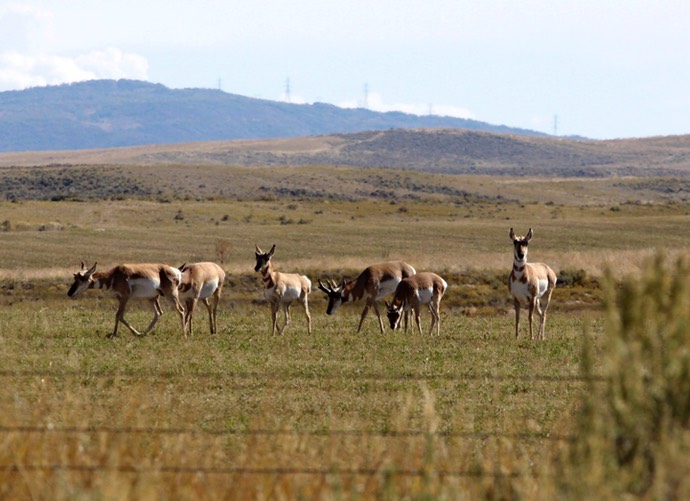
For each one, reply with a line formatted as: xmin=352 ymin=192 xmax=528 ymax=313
xmin=67 ymin=228 xmax=556 ymax=339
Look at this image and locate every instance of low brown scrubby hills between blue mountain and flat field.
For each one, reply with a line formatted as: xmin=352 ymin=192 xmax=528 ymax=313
xmin=0 ymin=129 xmax=690 ymax=205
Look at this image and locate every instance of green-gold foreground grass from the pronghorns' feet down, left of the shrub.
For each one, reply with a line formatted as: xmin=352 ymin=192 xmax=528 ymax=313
xmin=0 ymin=302 xmax=590 ymax=499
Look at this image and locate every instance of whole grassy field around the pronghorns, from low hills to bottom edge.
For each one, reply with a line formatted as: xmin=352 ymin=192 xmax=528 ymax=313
xmin=0 ymin=194 xmax=690 ymax=499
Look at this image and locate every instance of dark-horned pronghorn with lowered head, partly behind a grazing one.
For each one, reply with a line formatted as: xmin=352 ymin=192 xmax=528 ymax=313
xmin=319 ymin=261 xmax=416 ymax=334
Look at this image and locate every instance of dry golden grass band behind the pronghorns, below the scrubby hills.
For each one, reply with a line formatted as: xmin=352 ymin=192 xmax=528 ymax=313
xmin=0 ymin=196 xmax=690 ymax=278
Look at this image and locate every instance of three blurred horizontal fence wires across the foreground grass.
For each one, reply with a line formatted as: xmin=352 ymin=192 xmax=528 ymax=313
xmin=0 ymin=370 xmax=606 ymax=479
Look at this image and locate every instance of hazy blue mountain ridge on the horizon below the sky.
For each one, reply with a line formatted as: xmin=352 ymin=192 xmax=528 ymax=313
xmin=0 ymin=80 xmax=545 ymax=152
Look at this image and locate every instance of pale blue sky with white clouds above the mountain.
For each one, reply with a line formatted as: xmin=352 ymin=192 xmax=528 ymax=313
xmin=0 ymin=0 xmax=690 ymax=139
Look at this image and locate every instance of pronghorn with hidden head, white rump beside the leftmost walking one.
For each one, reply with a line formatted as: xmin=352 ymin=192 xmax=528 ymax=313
xmin=179 ymin=262 xmax=225 ymax=335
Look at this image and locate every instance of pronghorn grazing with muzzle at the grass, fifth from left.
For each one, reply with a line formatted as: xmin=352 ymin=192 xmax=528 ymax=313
xmin=386 ymin=273 xmax=448 ymax=336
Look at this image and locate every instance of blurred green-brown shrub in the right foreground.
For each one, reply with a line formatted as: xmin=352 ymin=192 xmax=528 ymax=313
xmin=561 ymin=254 xmax=690 ymax=499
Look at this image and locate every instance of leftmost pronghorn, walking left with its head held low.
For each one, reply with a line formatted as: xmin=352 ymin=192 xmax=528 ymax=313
xmin=67 ymin=261 xmax=186 ymax=338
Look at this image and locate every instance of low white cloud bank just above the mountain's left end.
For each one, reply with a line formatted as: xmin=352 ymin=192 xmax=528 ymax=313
xmin=0 ymin=48 xmax=148 ymax=90
